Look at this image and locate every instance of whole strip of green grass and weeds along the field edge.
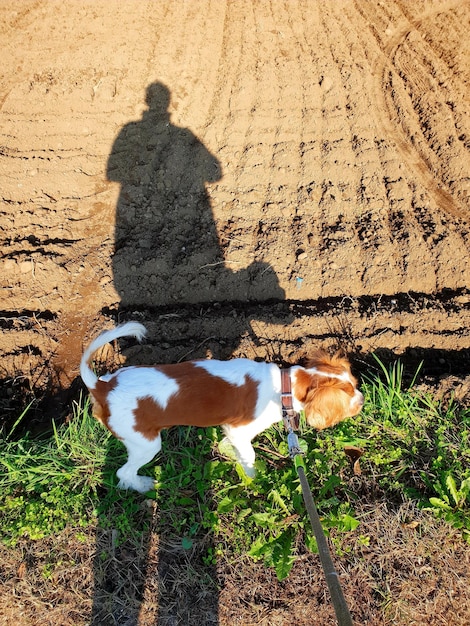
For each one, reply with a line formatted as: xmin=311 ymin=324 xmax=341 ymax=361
xmin=0 ymin=361 xmax=470 ymax=579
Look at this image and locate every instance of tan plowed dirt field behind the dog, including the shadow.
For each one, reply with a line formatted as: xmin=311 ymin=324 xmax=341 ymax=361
xmin=0 ymin=0 xmax=470 ymax=624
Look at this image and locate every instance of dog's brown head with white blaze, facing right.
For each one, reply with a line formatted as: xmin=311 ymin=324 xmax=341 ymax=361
xmin=293 ymin=351 xmax=364 ymax=430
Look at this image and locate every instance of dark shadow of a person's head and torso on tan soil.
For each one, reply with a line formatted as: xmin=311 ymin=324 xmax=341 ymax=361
xmin=107 ymin=82 xmax=284 ymax=310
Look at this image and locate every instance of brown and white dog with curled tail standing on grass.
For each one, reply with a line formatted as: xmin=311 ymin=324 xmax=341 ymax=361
xmin=80 ymin=322 xmax=364 ymax=493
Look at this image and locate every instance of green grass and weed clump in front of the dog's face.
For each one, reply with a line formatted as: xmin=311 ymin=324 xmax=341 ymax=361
xmin=354 ymin=361 xmax=470 ymax=541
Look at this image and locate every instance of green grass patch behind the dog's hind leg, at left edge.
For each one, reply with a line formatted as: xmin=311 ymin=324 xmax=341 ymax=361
xmin=0 ymin=399 xmax=147 ymax=545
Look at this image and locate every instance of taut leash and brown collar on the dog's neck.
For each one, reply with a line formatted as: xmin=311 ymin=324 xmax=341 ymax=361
xmin=281 ymin=369 xmax=353 ymax=626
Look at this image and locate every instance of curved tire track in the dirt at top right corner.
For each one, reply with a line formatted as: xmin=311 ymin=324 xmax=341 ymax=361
xmin=355 ymin=0 xmax=470 ymax=222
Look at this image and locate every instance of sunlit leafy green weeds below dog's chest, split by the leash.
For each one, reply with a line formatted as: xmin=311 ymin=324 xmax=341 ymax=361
xmin=200 ymin=426 xmax=358 ymax=580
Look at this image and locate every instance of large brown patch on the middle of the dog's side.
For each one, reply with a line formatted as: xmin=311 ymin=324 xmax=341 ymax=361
xmin=134 ymin=362 xmax=258 ymax=440
